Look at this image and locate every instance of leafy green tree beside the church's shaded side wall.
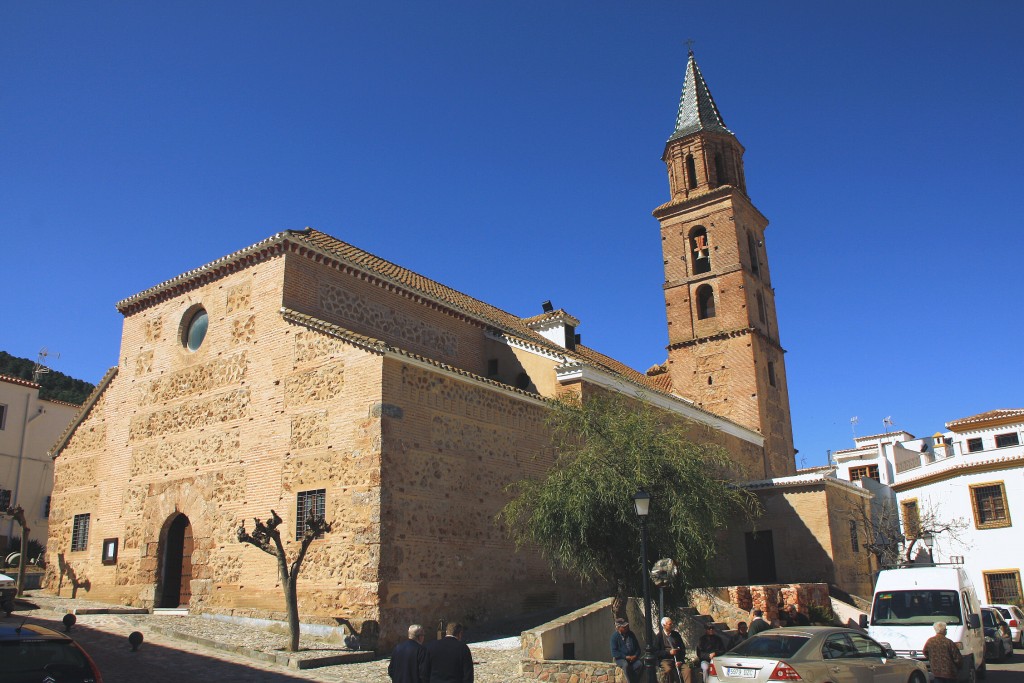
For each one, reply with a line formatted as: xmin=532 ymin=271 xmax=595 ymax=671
xmin=498 ymin=394 xmax=760 ymax=604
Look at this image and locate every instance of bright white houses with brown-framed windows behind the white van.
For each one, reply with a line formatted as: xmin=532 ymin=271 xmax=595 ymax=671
xmin=833 ymin=409 xmax=1024 ymax=603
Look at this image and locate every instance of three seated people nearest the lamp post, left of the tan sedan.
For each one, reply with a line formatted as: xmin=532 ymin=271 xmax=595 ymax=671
xmin=611 ymin=616 xmax=733 ymax=683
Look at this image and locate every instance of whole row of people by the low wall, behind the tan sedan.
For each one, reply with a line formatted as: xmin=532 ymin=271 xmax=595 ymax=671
xmin=611 ymin=605 xmax=810 ymax=683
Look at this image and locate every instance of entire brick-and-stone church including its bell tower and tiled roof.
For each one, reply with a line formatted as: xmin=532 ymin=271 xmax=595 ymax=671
xmin=47 ymin=53 xmax=872 ymax=647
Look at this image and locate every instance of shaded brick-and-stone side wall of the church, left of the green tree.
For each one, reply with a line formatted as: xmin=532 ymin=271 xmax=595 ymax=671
xmin=381 ymin=360 xmax=584 ymax=642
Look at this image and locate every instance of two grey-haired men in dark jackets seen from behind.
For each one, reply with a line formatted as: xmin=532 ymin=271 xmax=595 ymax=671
xmin=387 ymin=622 xmax=473 ymax=683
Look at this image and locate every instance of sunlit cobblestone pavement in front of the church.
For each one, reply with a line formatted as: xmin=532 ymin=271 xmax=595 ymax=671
xmin=9 ymin=592 xmax=527 ymax=683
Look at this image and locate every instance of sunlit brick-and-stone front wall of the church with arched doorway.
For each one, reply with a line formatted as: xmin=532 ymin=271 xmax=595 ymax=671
xmin=48 ymin=258 xmax=382 ymax=643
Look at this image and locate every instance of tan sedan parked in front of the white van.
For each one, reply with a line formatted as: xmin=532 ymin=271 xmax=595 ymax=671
xmin=708 ymin=626 xmax=928 ymax=683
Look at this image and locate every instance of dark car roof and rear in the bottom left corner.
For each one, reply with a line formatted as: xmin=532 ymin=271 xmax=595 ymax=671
xmin=0 ymin=620 xmax=103 ymax=683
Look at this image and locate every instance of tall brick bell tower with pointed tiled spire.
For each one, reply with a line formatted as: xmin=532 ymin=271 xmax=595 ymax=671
xmin=654 ymin=51 xmax=796 ymax=478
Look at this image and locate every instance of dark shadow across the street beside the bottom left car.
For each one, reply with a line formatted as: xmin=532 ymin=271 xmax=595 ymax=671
xmin=0 ymin=612 xmax=317 ymax=683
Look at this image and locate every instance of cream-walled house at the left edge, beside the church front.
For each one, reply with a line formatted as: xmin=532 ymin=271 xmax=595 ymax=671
xmin=0 ymin=375 xmax=79 ymax=552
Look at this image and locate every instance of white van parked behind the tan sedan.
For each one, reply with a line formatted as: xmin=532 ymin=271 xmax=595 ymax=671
xmin=867 ymin=565 xmax=986 ymax=683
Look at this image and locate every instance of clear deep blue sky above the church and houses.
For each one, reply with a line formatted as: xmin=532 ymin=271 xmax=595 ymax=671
xmin=0 ymin=0 xmax=1024 ymax=466
